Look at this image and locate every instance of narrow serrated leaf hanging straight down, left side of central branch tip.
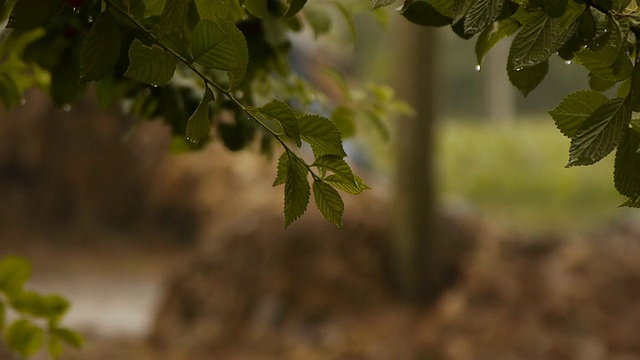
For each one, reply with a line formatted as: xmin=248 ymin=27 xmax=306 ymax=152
xmin=284 ymin=154 xmax=311 ymax=228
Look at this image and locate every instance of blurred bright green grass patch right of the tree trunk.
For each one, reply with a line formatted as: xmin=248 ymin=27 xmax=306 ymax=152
xmin=437 ymin=117 xmax=637 ymax=233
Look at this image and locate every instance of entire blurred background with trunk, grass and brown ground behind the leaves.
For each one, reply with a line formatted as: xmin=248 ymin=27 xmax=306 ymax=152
xmin=0 ymin=4 xmax=640 ymax=360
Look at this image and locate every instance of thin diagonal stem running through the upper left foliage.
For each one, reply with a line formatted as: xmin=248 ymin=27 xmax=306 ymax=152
xmin=104 ymin=0 xmax=320 ymax=180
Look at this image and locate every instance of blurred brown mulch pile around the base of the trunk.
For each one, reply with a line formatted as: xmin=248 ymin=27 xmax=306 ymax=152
xmin=131 ymin=200 xmax=640 ymax=360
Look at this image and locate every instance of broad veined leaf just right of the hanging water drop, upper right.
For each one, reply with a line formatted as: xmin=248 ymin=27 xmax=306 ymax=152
xmin=509 ymin=11 xmax=559 ymax=70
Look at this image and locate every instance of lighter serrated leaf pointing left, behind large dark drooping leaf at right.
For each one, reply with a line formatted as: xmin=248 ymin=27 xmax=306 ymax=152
xmin=549 ymin=90 xmax=609 ymax=138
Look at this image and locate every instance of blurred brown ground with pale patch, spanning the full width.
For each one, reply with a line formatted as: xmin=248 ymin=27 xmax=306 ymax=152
xmin=0 ymin=93 xmax=640 ymax=360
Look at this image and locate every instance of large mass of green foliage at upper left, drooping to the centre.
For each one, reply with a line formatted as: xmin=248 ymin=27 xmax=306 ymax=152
xmin=0 ymin=0 xmax=420 ymax=228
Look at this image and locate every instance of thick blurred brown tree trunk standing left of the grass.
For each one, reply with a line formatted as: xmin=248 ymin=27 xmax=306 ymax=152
xmin=393 ymin=21 xmax=446 ymax=303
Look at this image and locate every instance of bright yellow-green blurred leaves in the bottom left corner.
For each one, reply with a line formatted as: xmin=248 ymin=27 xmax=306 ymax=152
xmin=0 ymin=256 xmax=84 ymax=359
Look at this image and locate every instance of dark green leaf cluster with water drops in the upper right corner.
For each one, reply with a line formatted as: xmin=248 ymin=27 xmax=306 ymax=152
xmin=374 ymin=0 xmax=640 ymax=207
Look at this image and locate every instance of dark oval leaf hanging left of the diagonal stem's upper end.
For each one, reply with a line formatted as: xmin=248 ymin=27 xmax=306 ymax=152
xmin=80 ymin=11 xmax=122 ymax=82
